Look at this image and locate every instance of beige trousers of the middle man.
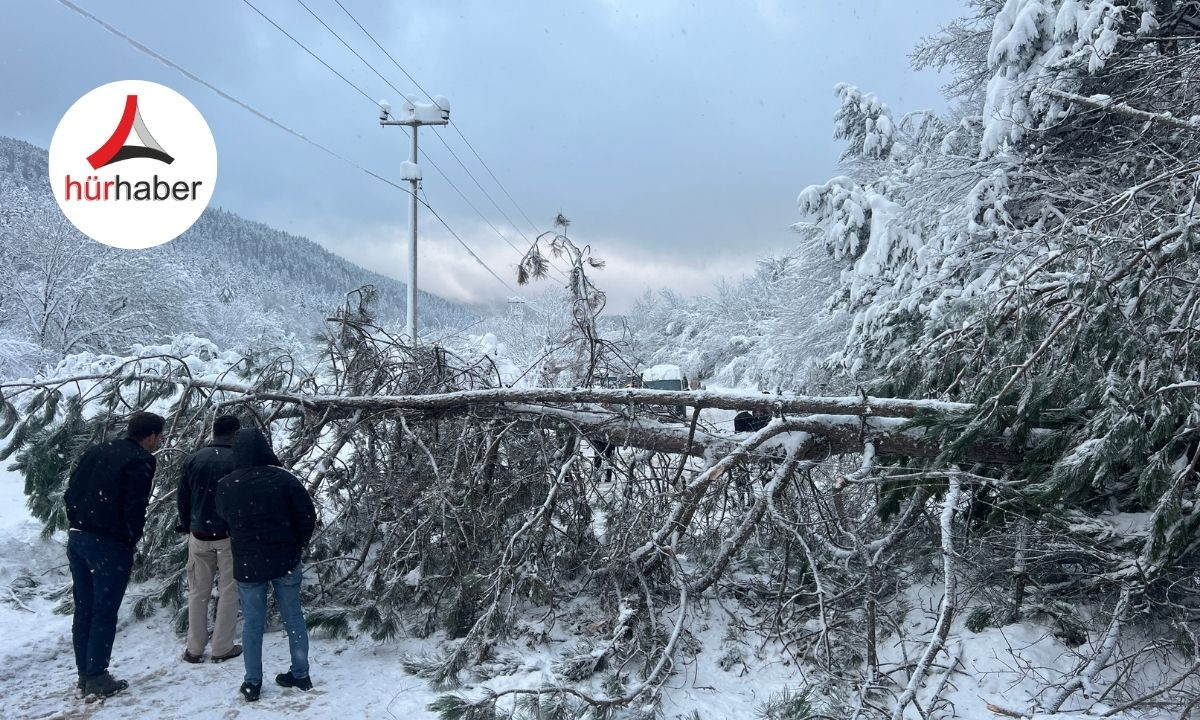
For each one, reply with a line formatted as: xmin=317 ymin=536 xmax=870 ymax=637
xmin=187 ymin=534 xmax=238 ymax=655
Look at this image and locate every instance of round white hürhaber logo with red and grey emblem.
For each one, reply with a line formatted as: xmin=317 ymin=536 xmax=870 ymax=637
xmin=49 ymin=80 xmax=217 ymax=250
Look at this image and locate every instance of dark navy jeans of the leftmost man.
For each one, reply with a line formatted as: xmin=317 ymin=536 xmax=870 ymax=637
xmin=67 ymin=530 xmax=133 ymax=677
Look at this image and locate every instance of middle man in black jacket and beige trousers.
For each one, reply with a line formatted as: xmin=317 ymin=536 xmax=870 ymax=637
xmin=175 ymin=415 xmax=241 ymax=662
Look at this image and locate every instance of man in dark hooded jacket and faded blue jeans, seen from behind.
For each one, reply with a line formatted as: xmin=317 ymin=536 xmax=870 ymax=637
xmin=216 ymin=428 xmax=317 ymax=701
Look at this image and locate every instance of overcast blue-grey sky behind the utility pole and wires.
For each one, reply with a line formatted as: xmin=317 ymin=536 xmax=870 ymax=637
xmin=0 ymin=0 xmax=960 ymax=311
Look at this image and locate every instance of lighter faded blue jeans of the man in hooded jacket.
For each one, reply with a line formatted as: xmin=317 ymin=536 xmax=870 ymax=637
xmin=238 ymin=563 xmax=308 ymax=684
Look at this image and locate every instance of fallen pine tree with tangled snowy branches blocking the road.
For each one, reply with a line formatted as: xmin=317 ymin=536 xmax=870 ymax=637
xmin=0 ymin=302 xmax=1190 ymax=718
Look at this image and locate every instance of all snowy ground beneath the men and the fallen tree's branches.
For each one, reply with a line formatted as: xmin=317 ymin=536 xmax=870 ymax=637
xmin=0 ymin=456 xmax=1166 ymax=720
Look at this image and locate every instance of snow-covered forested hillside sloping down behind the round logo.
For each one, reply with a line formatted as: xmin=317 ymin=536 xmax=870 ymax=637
xmin=0 ymin=137 xmax=478 ymax=377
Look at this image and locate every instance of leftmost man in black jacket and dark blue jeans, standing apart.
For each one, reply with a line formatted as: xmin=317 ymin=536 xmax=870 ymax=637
xmin=64 ymin=413 xmax=164 ymax=696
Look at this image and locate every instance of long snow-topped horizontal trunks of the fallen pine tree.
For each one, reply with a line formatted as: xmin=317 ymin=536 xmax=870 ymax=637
xmin=0 ymin=370 xmax=1021 ymax=464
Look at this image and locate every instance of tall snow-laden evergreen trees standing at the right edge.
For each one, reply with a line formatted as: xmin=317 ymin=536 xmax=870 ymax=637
xmin=798 ymin=5 xmax=1200 ymax=709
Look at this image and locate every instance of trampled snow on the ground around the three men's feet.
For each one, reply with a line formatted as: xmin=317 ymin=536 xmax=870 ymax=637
xmin=0 ymin=472 xmax=448 ymax=720
